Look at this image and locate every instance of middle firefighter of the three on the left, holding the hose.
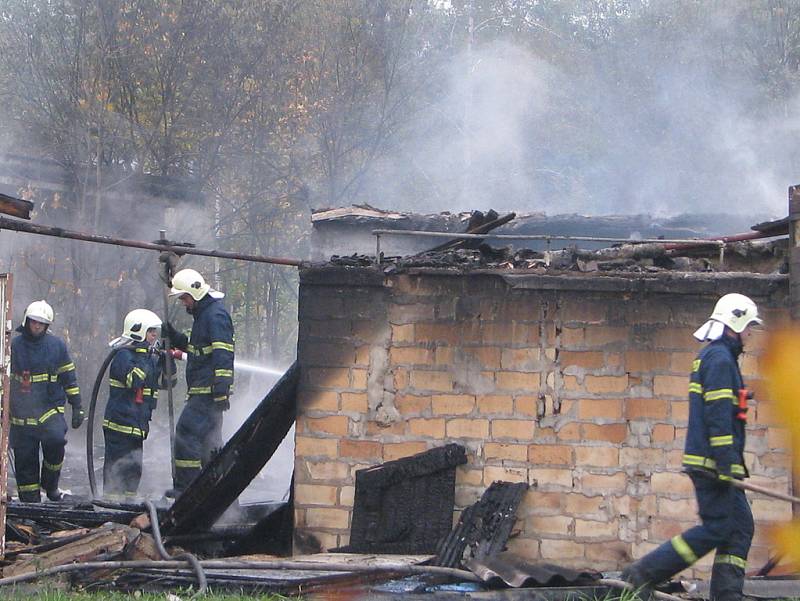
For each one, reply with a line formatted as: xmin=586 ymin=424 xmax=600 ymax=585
xmin=103 ymin=309 xmax=174 ymax=501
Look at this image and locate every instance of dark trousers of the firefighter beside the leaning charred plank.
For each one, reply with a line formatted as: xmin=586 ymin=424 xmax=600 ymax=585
xmin=174 ymin=394 xmax=222 ymax=493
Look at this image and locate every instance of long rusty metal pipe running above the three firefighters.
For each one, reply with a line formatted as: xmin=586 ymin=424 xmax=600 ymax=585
xmin=0 ymin=217 xmax=303 ymax=267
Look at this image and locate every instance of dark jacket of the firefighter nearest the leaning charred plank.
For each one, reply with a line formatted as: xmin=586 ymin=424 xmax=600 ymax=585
xmin=172 ymin=294 xmax=234 ymax=403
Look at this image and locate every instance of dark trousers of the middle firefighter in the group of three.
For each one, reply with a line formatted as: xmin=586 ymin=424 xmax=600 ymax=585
xmin=103 ymin=428 xmax=143 ymax=501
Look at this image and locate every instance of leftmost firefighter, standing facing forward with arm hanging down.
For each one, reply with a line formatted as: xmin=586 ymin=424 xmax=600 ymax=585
xmin=9 ymin=300 xmax=83 ymax=503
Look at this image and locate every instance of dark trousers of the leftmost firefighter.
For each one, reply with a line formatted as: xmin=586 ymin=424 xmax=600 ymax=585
xmin=9 ymin=413 xmax=67 ymax=503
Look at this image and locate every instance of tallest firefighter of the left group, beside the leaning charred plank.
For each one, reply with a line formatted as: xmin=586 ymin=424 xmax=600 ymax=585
xmin=164 ymin=269 xmax=234 ymax=496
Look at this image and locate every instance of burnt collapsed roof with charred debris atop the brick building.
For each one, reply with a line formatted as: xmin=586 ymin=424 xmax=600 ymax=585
xmin=312 ymin=205 xmax=788 ymax=274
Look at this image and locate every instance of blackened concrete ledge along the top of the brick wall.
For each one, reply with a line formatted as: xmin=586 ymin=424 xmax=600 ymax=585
xmin=300 ymin=264 xmax=789 ymax=298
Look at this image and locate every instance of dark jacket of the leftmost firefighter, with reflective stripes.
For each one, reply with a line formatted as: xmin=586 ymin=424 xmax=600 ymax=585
xmin=11 ymin=326 xmax=81 ymax=426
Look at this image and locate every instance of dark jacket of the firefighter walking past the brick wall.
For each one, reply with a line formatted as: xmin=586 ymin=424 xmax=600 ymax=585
xmin=683 ymin=336 xmax=749 ymax=478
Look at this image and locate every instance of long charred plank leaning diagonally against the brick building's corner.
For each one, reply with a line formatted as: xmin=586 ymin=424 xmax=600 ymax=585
xmin=161 ymin=363 xmax=300 ymax=535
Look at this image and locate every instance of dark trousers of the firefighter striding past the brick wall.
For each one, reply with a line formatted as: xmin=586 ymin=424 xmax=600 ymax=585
xmin=623 ymin=473 xmax=753 ymax=601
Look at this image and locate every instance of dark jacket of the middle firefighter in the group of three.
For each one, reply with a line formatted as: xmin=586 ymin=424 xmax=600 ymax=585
xmin=103 ymin=342 xmax=163 ymax=439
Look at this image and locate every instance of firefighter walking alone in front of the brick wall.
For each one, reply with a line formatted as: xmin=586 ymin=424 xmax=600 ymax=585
xmin=622 ymin=294 xmax=761 ymax=601
